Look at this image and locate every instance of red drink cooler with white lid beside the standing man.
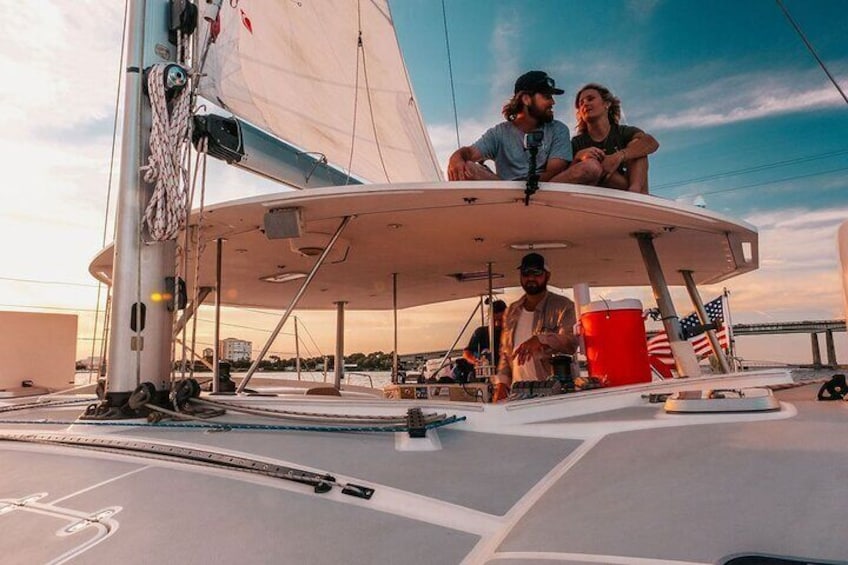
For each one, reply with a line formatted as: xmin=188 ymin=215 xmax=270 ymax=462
xmin=580 ymin=299 xmax=651 ymax=386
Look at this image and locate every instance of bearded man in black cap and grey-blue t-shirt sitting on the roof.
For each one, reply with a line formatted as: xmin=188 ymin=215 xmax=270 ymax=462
xmin=448 ymin=71 xmax=604 ymax=185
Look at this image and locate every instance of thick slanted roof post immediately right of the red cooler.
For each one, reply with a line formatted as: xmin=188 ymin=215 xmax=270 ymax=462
xmin=633 ymin=232 xmax=701 ymax=377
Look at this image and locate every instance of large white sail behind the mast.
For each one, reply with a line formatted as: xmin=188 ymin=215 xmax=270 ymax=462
xmin=196 ymin=0 xmax=442 ymax=182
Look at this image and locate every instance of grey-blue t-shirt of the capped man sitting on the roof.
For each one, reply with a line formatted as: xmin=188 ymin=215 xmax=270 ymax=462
xmin=474 ymin=120 xmax=572 ymax=180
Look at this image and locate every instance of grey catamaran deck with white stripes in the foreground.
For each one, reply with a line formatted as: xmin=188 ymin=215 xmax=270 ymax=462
xmin=0 ymin=373 xmax=848 ymax=564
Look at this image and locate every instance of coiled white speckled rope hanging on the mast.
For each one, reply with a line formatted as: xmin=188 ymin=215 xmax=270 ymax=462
xmin=144 ymin=64 xmax=191 ymax=241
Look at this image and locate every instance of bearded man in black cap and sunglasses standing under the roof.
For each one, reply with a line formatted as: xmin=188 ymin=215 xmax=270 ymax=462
xmin=492 ymin=253 xmax=577 ymax=402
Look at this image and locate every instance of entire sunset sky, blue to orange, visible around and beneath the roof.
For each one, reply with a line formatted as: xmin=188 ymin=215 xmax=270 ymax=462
xmin=0 ymin=0 xmax=848 ymax=360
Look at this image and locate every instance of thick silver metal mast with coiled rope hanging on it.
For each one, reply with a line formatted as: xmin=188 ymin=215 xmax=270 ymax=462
xmin=106 ymin=0 xmax=181 ymax=407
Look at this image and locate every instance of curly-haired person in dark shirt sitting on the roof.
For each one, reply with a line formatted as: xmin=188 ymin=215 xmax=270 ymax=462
xmin=571 ymin=83 xmax=660 ymax=194
